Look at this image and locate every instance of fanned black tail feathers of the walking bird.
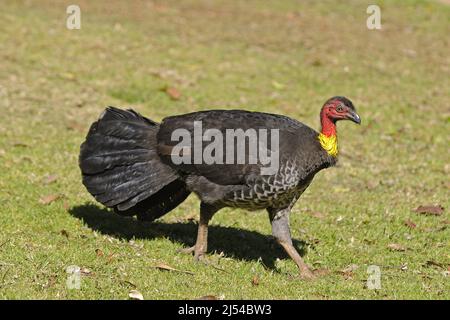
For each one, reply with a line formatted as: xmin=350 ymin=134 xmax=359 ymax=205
xmin=79 ymin=107 xmax=190 ymax=220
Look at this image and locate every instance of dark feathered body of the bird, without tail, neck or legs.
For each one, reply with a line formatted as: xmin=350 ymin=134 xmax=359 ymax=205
xmin=158 ymin=110 xmax=334 ymax=209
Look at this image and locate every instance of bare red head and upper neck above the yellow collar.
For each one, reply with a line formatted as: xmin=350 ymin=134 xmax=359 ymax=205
xmin=320 ymin=97 xmax=361 ymax=137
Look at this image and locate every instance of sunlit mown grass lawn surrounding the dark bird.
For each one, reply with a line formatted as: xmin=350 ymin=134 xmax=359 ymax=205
xmin=0 ymin=0 xmax=450 ymax=299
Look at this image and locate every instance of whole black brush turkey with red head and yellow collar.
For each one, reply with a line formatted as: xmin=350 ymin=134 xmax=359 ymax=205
xmin=79 ymin=97 xmax=360 ymax=278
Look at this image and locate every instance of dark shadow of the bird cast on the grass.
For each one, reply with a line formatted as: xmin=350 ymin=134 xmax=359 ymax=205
xmin=69 ymin=204 xmax=306 ymax=269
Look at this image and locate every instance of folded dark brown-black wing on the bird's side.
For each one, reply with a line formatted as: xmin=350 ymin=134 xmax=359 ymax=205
xmin=157 ymin=110 xmax=317 ymax=185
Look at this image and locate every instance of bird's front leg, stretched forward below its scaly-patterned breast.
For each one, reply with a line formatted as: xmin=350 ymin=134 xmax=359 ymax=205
xmin=268 ymin=208 xmax=314 ymax=279
